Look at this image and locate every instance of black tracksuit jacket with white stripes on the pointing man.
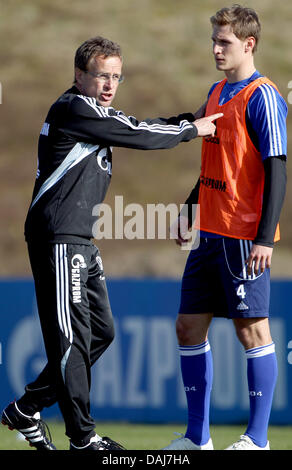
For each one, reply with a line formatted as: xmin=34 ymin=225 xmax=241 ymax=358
xmin=25 ymin=86 xmax=197 ymax=244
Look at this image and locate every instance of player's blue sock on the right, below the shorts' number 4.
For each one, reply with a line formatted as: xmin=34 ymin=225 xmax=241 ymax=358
xmin=245 ymin=343 xmax=278 ymax=447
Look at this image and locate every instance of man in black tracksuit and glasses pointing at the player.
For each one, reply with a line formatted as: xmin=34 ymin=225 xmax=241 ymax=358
xmin=2 ymin=37 xmax=220 ymax=450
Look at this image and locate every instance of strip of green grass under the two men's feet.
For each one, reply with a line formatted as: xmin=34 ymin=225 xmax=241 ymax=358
xmin=0 ymin=421 xmax=292 ymax=450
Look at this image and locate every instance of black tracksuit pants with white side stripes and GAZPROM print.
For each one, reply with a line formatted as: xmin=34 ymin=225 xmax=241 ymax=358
xmin=17 ymin=243 xmax=114 ymax=445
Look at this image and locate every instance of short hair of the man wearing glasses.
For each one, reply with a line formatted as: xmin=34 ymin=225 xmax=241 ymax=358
xmin=74 ymin=36 xmax=122 ymax=81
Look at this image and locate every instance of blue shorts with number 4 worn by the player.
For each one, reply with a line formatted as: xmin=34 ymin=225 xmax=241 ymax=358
xmin=179 ymin=237 xmax=270 ymax=318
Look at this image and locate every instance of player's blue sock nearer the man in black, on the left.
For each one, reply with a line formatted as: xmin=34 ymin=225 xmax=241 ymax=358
xmin=179 ymin=340 xmax=213 ymax=445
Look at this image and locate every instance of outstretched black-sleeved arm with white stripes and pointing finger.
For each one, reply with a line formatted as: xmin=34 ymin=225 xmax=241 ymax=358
xmin=61 ymin=96 xmax=221 ymax=150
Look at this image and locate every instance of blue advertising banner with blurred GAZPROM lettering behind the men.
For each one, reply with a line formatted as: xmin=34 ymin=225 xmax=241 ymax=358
xmin=0 ymin=279 xmax=292 ymax=424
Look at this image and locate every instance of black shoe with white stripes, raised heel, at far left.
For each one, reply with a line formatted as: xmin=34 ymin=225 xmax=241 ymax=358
xmin=2 ymin=401 xmax=56 ymax=450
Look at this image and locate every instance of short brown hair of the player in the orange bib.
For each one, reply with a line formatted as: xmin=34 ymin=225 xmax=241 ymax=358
xmin=210 ymin=4 xmax=261 ymax=52
